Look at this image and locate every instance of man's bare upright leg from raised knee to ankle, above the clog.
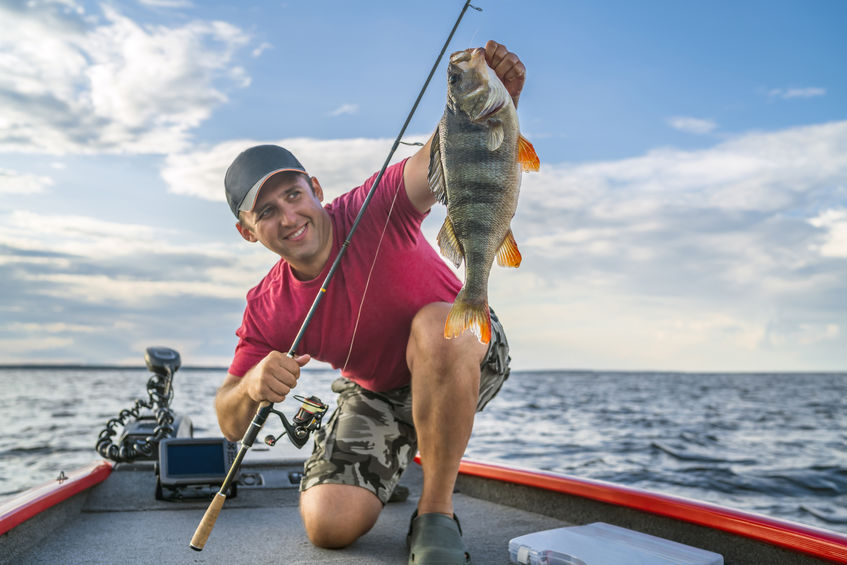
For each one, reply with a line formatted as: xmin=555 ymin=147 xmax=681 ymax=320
xmin=406 ymin=303 xmax=488 ymax=516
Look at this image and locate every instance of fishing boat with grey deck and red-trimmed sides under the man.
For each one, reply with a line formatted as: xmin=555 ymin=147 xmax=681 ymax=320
xmin=0 ymin=350 xmax=847 ymax=565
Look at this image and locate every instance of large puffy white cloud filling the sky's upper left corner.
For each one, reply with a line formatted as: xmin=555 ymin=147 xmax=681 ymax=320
xmin=0 ymin=1 xmax=249 ymax=154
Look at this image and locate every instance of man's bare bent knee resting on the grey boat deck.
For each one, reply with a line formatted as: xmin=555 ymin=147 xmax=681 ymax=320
xmin=300 ymin=484 xmax=382 ymax=549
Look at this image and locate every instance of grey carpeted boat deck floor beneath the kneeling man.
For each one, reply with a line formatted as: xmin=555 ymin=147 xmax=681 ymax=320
xmin=0 ymin=442 xmax=567 ymax=565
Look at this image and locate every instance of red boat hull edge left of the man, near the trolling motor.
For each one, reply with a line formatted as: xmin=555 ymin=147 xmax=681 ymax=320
xmin=0 ymin=461 xmax=112 ymax=535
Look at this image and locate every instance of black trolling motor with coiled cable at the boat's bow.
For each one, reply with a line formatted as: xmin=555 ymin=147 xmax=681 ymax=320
xmin=95 ymin=347 xmax=192 ymax=463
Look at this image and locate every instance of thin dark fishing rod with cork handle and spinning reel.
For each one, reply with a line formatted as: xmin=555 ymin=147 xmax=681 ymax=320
xmin=190 ymin=0 xmax=482 ymax=551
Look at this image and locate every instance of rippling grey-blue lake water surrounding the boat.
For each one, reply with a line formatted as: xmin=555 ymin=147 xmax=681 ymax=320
xmin=0 ymin=369 xmax=847 ymax=533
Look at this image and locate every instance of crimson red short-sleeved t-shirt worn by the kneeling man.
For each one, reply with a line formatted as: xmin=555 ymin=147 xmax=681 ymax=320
xmin=229 ymin=161 xmax=462 ymax=392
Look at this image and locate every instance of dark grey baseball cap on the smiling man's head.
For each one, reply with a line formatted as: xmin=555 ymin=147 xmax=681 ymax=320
xmin=224 ymin=145 xmax=307 ymax=218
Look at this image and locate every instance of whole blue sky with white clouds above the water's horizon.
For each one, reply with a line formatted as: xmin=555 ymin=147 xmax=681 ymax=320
xmin=0 ymin=0 xmax=847 ymax=371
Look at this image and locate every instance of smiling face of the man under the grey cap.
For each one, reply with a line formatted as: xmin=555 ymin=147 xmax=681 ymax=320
xmin=236 ymin=172 xmax=332 ymax=279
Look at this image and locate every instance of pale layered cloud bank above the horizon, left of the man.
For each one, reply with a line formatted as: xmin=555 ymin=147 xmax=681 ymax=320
xmin=0 ymin=205 xmax=275 ymax=365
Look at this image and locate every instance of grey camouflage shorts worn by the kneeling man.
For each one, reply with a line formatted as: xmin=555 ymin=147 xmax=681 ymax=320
xmin=300 ymin=311 xmax=510 ymax=504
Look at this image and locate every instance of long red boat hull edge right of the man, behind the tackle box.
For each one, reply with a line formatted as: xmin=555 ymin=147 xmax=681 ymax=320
xmin=458 ymin=458 xmax=847 ymax=564
